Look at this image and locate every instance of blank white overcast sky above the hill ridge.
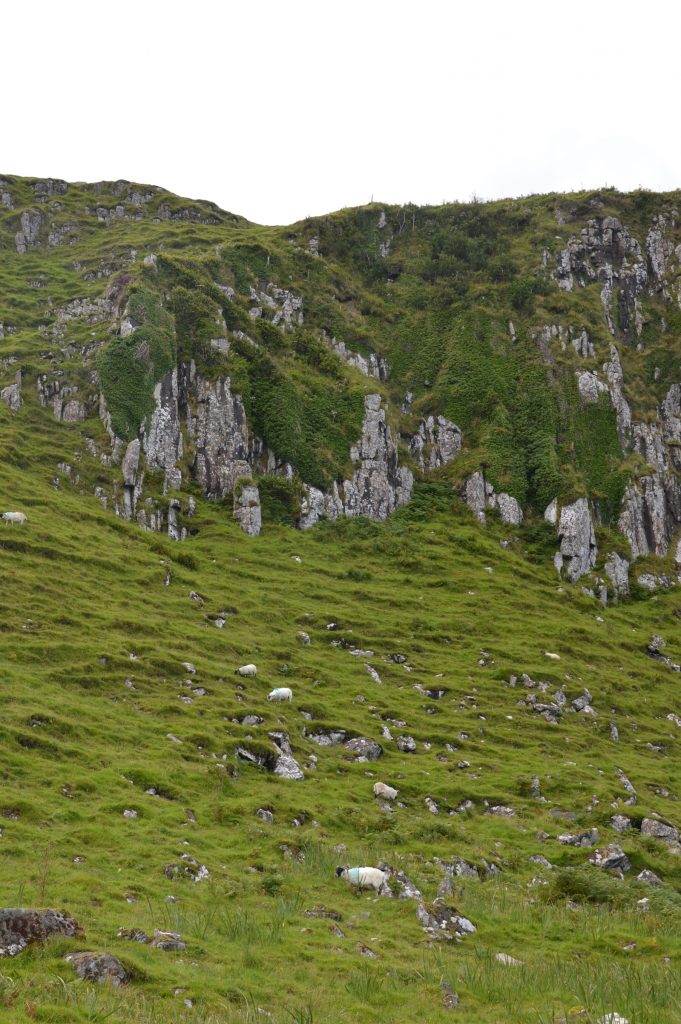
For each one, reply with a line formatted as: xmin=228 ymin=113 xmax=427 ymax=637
xmin=5 ymin=0 xmax=681 ymax=223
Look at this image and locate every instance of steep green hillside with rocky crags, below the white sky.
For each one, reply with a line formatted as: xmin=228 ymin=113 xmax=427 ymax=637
xmin=0 ymin=177 xmax=681 ymax=1024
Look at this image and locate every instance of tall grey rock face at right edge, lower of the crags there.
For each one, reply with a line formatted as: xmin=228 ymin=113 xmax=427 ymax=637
xmin=618 ymin=384 xmax=681 ymax=558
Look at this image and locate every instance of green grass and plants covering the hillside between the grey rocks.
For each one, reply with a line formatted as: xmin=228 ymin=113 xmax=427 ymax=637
xmin=0 ymin=179 xmax=681 ymax=1024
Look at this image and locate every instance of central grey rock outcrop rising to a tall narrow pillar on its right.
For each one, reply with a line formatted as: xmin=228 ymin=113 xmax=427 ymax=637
xmin=299 ymin=394 xmax=414 ymax=529
